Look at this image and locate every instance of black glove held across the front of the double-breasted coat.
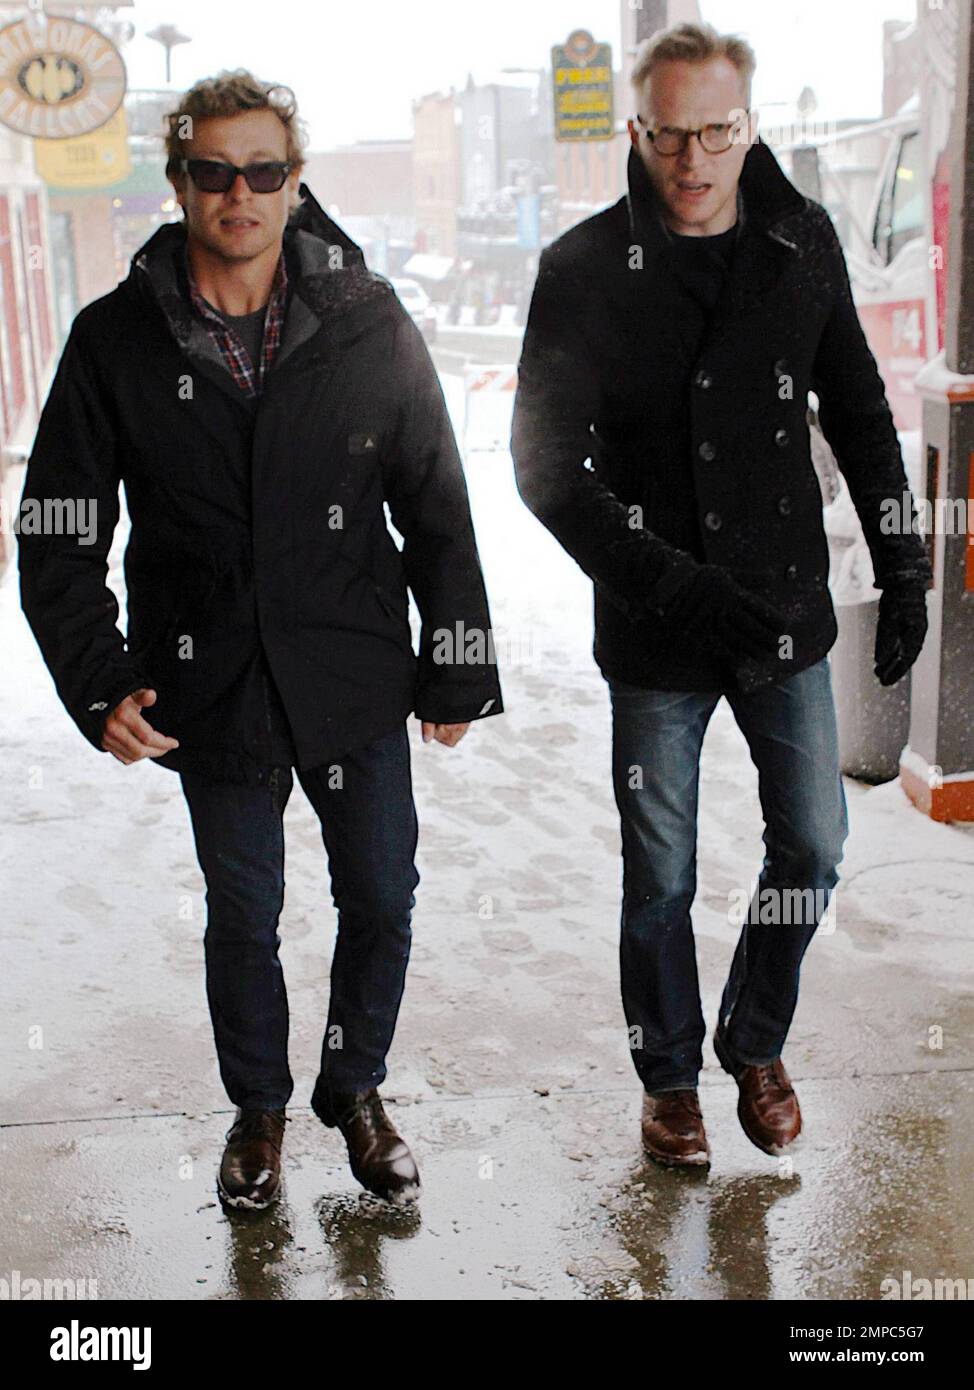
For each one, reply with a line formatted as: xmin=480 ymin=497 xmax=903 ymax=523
xmin=661 ymin=564 xmax=785 ymax=667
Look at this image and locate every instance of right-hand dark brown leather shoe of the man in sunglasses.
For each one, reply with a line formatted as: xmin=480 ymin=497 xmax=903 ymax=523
xmin=311 ymin=1088 xmax=420 ymax=1205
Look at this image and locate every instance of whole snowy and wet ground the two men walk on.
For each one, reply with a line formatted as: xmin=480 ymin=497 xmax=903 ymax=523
xmin=0 ymin=417 xmax=974 ymax=1300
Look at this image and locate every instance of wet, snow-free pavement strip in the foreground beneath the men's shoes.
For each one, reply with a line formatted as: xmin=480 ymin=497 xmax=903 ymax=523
xmin=3 ymin=1072 xmax=974 ymax=1300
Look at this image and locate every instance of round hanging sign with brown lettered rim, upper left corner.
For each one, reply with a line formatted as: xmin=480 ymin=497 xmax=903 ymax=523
xmin=0 ymin=15 xmax=125 ymax=140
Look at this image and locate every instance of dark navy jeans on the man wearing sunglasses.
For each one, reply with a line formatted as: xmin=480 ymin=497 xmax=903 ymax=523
xmin=182 ymin=724 xmax=420 ymax=1109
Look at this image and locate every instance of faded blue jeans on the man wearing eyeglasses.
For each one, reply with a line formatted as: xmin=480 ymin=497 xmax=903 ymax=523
xmin=609 ymin=659 xmax=849 ymax=1093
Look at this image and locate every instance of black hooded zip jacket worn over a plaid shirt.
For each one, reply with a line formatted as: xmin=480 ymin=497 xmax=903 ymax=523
xmin=18 ymin=185 xmax=503 ymax=784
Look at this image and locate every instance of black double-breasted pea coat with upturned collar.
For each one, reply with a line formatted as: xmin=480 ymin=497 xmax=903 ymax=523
xmin=511 ymin=140 xmax=930 ymax=691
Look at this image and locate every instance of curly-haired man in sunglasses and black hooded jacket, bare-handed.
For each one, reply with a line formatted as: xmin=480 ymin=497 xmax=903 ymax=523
xmin=19 ymin=72 xmax=502 ymax=1208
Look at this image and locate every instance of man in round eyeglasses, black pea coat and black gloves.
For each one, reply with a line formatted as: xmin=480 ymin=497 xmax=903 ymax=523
xmin=511 ymin=25 xmax=930 ymax=1168
